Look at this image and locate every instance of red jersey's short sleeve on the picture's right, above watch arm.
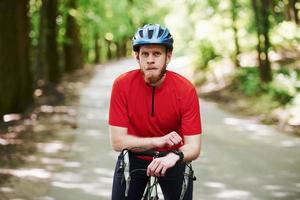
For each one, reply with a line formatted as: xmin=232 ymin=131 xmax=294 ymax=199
xmin=180 ymin=88 xmax=202 ymax=135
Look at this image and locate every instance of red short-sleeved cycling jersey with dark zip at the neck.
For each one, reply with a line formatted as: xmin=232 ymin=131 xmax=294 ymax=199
xmin=109 ymin=70 xmax=201 ymax=150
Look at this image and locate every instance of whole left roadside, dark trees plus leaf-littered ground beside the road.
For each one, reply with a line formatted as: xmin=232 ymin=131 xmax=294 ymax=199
xmin=0 ymin=0 xmax=165 ymax=191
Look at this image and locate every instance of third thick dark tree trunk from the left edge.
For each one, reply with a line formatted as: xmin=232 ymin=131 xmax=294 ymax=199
xmin=64 ymin=0 xmax=83 ymax=72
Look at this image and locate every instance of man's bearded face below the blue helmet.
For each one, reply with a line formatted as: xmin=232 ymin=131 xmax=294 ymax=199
xmin=135 ymin=45 xmax=172 ymax=86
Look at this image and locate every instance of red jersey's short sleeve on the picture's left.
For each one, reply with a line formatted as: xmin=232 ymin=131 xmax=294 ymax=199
xmin=108 ymin=79 xmax=129 ymax=127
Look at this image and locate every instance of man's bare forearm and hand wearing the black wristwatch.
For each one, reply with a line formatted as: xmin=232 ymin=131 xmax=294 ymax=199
xmin=147 ymin=134 xmax=201 ymax=176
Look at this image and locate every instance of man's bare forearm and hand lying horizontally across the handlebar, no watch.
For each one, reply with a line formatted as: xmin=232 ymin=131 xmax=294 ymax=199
xmin=109 ymin=125 xmax=182 ymax=151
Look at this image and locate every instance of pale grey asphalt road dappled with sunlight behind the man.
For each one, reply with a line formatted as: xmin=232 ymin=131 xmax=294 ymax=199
xmin=37 ymin=59 xmax=300 ymax=200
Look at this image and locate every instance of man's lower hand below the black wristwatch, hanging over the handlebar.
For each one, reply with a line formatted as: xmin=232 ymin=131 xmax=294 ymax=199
xmin=147 ymin=153 xmax=179 ymax=177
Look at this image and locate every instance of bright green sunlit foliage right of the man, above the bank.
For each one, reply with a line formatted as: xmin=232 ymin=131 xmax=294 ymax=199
xmin=177 ymin=0 xmax=300 ymax=104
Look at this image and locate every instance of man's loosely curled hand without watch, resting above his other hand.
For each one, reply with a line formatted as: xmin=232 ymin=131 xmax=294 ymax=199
xmin=154 ymin=131 xmax=183 ymax=147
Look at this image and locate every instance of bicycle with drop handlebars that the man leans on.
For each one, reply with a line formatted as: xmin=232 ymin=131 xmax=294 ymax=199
xmin=120 ymin=147 xmax=196 ymax=200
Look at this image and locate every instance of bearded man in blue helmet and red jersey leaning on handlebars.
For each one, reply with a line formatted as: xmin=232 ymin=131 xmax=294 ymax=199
xmin=109 ymin=24 xmax=201 ymax=200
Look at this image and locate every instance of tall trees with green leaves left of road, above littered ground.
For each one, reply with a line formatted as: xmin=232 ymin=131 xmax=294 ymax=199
xmin=0 ymin=0 xmax=165 ymax=116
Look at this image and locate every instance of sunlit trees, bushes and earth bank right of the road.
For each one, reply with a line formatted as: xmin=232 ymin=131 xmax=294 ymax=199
xmin=161 ymin=0 xmax=300 ymax=135
